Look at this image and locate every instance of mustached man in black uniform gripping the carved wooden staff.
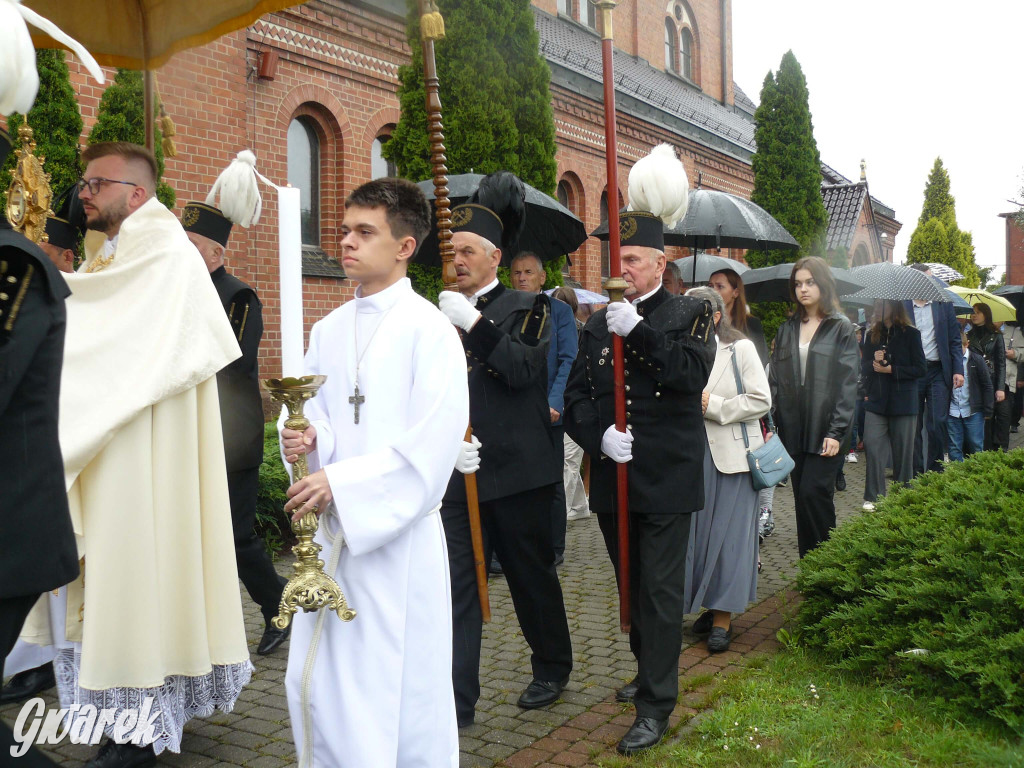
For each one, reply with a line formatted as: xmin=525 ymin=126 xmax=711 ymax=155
xmin=440 ymin=176 xmax=572 ymax=727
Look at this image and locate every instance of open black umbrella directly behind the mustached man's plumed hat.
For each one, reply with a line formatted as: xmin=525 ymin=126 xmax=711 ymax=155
xmin=416 ymin=173 xmax=587 ymax=266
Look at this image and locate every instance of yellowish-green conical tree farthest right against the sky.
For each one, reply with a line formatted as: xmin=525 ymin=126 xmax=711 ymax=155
xmin=906 ymin=158 xmax=981 ymax=288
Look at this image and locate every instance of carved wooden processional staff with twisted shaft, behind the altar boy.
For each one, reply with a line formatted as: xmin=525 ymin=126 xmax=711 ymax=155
xmin=419 ymin=0 xmax=491 ymax=622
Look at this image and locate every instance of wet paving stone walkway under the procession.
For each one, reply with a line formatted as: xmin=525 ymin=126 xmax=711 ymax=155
xmin=0 ymin=444 xmax=876 ymax=768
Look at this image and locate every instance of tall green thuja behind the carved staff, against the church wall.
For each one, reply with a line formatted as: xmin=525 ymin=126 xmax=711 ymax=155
xmin=384 ymin=0 xmax=561 ymax=295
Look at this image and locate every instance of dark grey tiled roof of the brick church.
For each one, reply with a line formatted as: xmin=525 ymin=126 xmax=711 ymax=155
xmin=534 ymin=7 xmax=754 ymax=162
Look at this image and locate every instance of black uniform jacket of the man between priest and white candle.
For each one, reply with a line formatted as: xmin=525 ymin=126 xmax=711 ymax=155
xmin=210 ymin=266 xmax=263 ymax=472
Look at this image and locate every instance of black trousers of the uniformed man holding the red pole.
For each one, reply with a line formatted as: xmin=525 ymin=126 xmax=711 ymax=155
xmin=597 ymin=514 xmax=690 ymax=720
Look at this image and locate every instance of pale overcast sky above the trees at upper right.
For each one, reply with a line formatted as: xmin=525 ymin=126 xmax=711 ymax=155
xmin=732 ymin=0 xmax=1024 ymax=279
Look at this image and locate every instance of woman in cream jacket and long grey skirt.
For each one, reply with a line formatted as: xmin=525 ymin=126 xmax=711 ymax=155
xmin=684 ymin=288 xmax=771 ymax=653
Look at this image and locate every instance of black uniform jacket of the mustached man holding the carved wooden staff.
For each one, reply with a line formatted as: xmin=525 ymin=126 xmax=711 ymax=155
xmin=444 ymin=284 xmax=562 ymax=503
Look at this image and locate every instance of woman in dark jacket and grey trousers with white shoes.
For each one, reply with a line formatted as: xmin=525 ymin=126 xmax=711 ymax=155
xmin=860 ymin=301 xmax=928 ymax=511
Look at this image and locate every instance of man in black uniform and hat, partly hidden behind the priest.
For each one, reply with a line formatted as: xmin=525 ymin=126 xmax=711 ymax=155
xmin=181 ymin=203 xmax=291 ymax=655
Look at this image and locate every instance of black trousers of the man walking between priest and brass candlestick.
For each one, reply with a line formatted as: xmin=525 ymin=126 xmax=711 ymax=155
xmin=227 ymin=468 xmax=285 ymax=622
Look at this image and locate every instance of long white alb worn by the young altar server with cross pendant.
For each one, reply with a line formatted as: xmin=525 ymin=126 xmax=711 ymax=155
xmin=286 ymin=278 xmax=469 ymax=768
